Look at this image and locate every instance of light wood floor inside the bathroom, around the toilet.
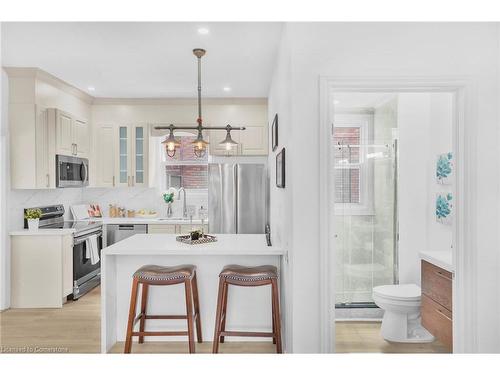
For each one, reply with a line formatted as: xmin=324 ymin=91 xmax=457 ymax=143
xmin=335 ymin=322 xmax=449 ymax=353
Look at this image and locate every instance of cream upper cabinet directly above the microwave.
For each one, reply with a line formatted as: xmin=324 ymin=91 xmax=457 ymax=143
xmin=54 ymin=109 xmax=90 ymax=157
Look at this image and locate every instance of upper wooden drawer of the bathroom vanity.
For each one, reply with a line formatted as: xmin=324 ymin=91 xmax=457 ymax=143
xmin=422 ymin=260 xmax=453 ymax=311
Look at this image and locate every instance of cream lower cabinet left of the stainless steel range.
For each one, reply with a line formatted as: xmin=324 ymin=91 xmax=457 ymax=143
xmin=11 ymin=233 xmax=73 ymax=308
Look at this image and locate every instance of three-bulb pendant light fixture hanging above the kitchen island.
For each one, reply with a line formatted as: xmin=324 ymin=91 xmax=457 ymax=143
xmin=155 ymin=48 xmax=245 ymax=158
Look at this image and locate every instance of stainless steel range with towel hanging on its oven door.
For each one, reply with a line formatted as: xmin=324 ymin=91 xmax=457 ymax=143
xmin=24 ymin=204 xmax=102 ymax=300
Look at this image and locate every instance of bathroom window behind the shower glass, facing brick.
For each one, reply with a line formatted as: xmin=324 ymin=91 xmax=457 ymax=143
xmin=333 ymin=114 xmax=373 ymax=215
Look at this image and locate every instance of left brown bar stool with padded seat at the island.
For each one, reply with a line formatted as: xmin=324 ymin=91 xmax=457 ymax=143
xmin=124 ymin=264 xmax=203 ymax=353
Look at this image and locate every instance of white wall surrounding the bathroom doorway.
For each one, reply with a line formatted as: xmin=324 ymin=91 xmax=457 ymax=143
xmin=269 ymin=23 xmax=500 ymax=352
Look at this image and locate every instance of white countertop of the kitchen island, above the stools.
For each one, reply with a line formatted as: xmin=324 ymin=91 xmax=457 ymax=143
xmin=103 ymin=234 xmax=285 ymax=256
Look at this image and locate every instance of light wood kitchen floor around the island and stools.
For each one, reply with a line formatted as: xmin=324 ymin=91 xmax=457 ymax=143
xmin=0 ymin=288 xmax=276 ymax=353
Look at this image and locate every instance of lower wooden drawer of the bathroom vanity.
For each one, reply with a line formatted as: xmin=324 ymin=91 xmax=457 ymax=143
xmin=421 ymin=294 xmax=453 ymax=350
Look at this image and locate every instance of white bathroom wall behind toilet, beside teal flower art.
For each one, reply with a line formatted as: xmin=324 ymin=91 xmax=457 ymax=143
xmin=398 ymin=93 xmax=453 ymax=285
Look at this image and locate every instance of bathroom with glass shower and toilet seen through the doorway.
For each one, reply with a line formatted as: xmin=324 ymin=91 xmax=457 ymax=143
xmin=330 ymin=90 xmax=456 ymax=353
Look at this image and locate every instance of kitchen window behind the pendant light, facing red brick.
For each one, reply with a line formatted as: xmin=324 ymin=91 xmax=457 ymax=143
xmin=160 ymin=135 xmax=208 ymax=189
